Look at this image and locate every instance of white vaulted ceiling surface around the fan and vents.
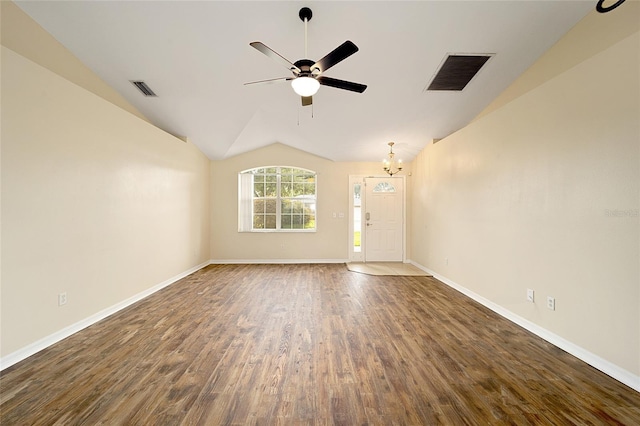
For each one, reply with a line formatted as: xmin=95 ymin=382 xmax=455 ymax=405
xmin=17 ymin=0 xmax=596 ymax=161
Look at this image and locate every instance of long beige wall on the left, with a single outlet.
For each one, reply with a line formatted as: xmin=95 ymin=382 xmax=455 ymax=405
xmin=1 ymin=46 xmax=210 ymax=356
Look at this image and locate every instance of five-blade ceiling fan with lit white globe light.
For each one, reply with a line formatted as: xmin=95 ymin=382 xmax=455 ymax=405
xmin=245 ymin=7 xmax=367 ymax=106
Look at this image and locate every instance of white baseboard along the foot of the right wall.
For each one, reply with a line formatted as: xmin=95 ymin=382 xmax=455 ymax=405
xmin=409 ymin=261 xmax=640 ymax=392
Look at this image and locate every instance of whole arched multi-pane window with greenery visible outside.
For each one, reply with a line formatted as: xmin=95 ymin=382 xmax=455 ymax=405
xmin=239 ymin=166 xmax=316 ymax=231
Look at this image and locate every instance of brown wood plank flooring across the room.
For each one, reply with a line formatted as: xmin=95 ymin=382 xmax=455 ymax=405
xmin=0 ymin=264 xmax=640 ymax=425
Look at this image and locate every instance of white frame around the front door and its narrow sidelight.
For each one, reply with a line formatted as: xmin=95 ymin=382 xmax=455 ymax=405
xmin=347 ymin=174 xmax=408 ymax=263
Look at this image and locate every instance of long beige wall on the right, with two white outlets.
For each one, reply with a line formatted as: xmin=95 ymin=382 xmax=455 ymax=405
xmin=412 ymin=6 xmax=640 ymax=377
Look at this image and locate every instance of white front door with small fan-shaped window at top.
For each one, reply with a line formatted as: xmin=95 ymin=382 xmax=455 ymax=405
xmin=363 ymin=177 xmax=404 ymax=262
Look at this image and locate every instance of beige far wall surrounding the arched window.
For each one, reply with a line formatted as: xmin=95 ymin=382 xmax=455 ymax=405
xmin=211 ymin=143 xmax=392 ymax=262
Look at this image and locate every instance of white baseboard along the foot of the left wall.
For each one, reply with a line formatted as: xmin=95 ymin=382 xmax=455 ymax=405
xmin=0 ymin=262 xmax=210 ymax=371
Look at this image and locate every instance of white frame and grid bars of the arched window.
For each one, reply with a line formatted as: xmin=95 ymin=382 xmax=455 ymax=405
xmin=238 ymin=166 xmax=318 ymax=233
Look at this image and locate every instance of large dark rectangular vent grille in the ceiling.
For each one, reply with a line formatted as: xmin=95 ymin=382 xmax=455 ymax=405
xmin=427 ymin=55 xmax=492 ymax=91
